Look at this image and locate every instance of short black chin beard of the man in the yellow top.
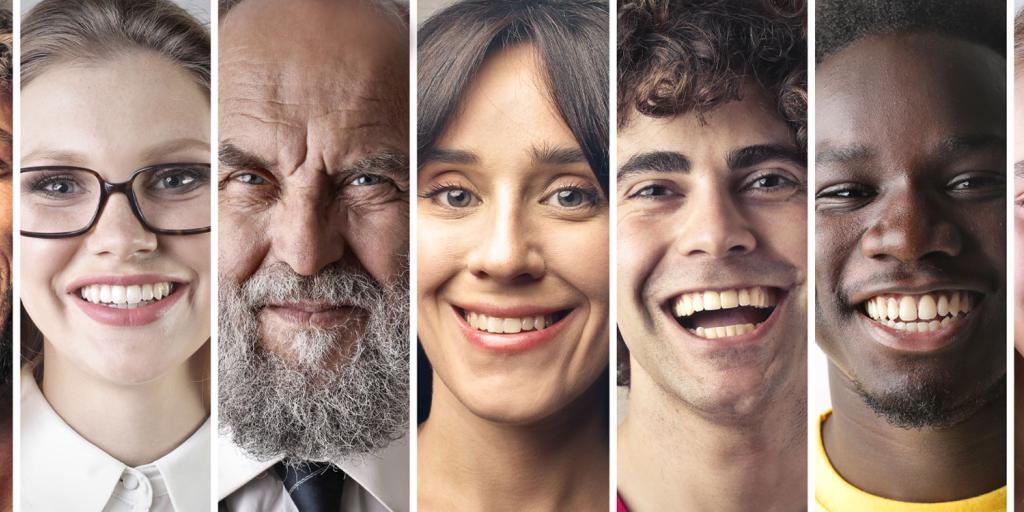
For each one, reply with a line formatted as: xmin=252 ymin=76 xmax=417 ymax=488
xmin=854 ymin=368 xmax=1007 ymax=429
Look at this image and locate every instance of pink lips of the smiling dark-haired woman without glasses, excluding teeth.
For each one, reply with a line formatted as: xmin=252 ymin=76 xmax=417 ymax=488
xmin=452 ymin=306 xmax=575 ymax=353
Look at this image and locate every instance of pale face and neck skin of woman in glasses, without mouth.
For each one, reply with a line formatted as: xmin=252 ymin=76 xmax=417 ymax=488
xmin=22 ymin=51 xmax=210 ymax=465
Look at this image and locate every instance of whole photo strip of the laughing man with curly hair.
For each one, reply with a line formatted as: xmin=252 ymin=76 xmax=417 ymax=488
xmin=615 ymin=0 xmax=808 ymax=512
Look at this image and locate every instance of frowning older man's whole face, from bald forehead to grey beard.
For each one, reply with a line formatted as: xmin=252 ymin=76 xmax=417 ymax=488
xmin=218 ymin=0 xmax=409 ymax=460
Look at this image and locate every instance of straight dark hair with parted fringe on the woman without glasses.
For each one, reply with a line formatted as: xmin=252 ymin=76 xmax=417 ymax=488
xmin=417 ymin=0 xmax=608 ymax=190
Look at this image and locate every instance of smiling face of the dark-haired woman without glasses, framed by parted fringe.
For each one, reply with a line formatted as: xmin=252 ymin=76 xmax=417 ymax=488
xmin=418 ymin=46 xmax=608 ymax=423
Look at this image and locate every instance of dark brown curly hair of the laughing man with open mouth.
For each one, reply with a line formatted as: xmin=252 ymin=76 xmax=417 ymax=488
xmin=618 ymin=0 xmax=807 ymax=147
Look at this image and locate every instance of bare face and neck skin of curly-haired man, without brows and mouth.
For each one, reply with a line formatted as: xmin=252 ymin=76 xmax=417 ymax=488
xmin=616 ymin=87 xmax=807 ymax=511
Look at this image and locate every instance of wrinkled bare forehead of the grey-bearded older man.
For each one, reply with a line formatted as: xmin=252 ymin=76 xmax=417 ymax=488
xmin=219 ymin=0 xmax=409 ymax=168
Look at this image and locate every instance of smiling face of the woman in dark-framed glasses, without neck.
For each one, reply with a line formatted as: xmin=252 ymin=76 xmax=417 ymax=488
xmin=15 ymin=52 xmax=210 ymax=384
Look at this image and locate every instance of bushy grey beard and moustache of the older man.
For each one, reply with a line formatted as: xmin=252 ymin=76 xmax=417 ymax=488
xmin=218 ymin=264 xmax=409 ymax=462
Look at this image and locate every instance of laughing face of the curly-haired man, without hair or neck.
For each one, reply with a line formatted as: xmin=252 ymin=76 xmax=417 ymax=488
xmin=617 ymin=88 xmax=807 ymax=418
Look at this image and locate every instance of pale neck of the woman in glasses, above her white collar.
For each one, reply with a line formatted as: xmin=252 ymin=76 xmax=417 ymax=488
xmin=41 ymin=342 xmax=208 ymax=467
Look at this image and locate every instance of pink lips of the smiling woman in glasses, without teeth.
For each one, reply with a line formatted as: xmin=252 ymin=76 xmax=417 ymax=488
xmin=65 ymin=274 xmax=189 ymax=327
